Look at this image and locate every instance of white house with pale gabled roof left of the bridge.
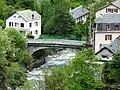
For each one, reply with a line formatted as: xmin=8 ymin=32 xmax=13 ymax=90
xmin=6 ymin=10 xmax=41 ymax=39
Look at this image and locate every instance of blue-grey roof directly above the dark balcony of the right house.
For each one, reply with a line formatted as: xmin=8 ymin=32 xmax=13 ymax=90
xmin=96 ymin=14 xmax=120 ymax=23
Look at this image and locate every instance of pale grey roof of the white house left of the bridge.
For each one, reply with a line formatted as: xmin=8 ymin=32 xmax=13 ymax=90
xmin=16 ymin=10 xmax=41 ymax=21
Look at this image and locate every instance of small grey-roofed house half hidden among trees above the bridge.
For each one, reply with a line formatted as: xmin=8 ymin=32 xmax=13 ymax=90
xmin=69 ymin=6 xmax=89 ymax=23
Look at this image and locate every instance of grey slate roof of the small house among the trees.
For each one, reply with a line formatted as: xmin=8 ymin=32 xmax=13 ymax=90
xmin=69 ymin=6 xmax=89 ymax=19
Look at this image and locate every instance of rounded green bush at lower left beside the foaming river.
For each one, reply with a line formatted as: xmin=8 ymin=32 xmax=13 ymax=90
xmin=7 ymin=62 xmax=26 ymax=90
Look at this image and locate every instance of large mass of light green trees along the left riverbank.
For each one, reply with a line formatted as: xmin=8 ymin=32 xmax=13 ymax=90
xmin=0 ymin=28 xmax=32 ymax=90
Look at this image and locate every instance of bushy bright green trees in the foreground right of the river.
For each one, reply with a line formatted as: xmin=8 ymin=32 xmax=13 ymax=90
xmin=45 ymin=49 xmax=102 ymax=90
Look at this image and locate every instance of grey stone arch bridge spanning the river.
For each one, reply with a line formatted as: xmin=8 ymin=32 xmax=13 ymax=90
xmin=27 ymin=39 xmax=85 ymax=54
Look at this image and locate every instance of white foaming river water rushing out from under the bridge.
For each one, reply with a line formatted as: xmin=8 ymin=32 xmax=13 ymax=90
xmin=27 ymin=49 xmax=77 ymax=90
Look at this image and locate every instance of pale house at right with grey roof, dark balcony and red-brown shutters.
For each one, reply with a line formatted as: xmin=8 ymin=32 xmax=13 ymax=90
xmin=95 ymin=14 xmax=120 ymax=53
